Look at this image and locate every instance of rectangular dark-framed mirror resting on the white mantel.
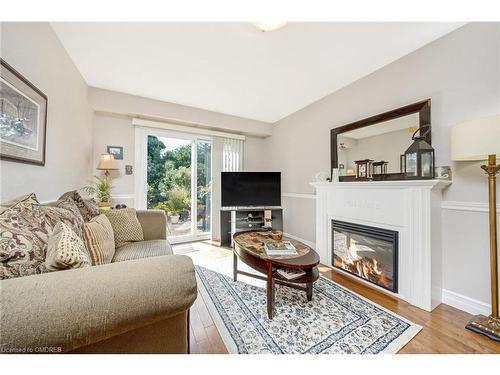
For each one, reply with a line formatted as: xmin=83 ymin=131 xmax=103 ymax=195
xmin=330 ymin=99 xmax=434 ymax=182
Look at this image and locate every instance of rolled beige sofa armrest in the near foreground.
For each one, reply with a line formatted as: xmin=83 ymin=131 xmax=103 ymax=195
xmin=0 ymin=255 xmax=197 ymax=353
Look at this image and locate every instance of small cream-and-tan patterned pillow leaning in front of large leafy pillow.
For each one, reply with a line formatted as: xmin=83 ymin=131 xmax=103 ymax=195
xmin=45 ymin=222 xmax=91 ymax=271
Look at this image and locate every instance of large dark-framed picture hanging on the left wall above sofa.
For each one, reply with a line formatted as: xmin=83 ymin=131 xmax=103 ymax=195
xmin=0 ymin=58 xmax=48 ymax=166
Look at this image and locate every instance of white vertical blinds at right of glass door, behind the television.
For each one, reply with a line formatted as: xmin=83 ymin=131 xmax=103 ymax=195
xmin=212 ymin=137 xmax=244 ymax=240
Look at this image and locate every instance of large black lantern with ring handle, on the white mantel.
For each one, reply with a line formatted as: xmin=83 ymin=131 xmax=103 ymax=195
xmin=405 ymin=125 xmax=434 ymax=178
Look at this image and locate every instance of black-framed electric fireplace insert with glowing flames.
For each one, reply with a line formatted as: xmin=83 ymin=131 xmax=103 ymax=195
xmin=332 ymin=220 xmax=398 ymax=293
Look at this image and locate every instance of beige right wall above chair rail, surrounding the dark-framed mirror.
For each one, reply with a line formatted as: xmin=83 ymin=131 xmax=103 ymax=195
xmin=268 ymin=23 xmax=500 ymax=201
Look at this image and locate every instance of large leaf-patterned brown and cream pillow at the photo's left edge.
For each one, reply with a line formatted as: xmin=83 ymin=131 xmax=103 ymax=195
xmin=0 ymin=194 xmax=52 ymax=279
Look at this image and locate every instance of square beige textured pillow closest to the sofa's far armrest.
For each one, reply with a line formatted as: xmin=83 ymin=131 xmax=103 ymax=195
xmin=104 ymin=208 xmax=144 ymax=248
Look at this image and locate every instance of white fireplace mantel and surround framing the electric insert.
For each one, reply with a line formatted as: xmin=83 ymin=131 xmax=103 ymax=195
xmin=311 ymin=180 xmax=451 ymax=311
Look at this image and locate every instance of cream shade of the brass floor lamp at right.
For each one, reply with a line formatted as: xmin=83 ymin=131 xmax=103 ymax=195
xmin=451 ymin=115 xmax=500 ymax=161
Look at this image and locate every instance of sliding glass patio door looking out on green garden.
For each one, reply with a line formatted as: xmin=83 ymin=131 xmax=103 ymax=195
xmin=146 ymin=130 xmax=212 ymax=243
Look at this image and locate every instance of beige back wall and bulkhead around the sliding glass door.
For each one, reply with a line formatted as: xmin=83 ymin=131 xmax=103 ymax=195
xmin=89 ymin=93 xmax=271 ymax=206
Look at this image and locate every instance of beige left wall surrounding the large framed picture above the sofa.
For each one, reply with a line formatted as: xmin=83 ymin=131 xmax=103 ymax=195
xmin=0 ymin=23 xmax=92 ymax=201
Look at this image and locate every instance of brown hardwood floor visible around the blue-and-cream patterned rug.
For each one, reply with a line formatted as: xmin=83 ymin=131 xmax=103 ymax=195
xmin=186 ymin=241 xmax=500 ymax=354
